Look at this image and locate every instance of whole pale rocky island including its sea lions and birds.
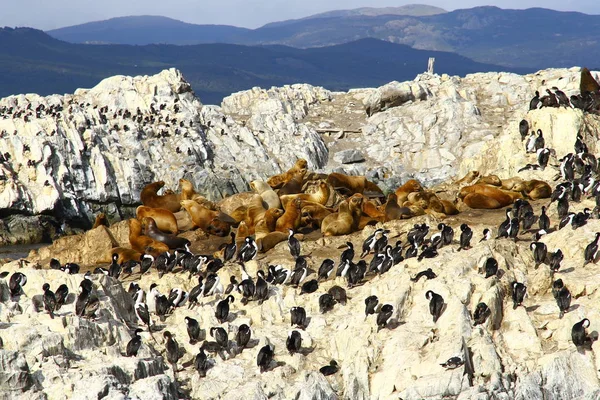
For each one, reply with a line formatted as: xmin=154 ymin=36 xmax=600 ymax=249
xmin=0 ymin=67 xmax=600 ymax=400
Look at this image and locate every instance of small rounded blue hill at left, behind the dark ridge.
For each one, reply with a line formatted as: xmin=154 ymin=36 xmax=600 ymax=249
xmin=48 ymin=15 xmax=250 ymax=45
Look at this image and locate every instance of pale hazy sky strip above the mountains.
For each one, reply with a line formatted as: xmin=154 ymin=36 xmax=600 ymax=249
xmin=0 ymin=0 xmax=600 ymax=30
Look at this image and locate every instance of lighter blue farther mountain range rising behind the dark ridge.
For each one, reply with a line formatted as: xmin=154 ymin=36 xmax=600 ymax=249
xmin=48 ymin=5 xmax=600 ymax=69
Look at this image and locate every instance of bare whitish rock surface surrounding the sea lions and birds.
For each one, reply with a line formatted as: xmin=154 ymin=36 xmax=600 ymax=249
xmin=0 ymin=69 xmax=600 ymax=400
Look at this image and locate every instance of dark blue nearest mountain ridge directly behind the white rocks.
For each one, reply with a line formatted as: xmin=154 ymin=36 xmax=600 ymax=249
xmin=0 ymin=28 xmax=529 ymax=104
